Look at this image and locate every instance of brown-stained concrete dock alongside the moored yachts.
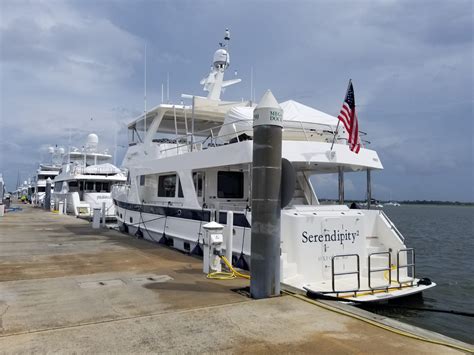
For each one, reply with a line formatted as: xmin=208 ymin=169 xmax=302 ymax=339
xmin=0 ymin=205 xmax=468 ymax=355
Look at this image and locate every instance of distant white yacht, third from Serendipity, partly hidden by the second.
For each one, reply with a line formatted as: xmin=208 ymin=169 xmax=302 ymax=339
xmin=31 ymin=147 xmax=64 ymax=207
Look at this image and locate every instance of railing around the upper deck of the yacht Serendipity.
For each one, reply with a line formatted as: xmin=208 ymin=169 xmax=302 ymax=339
xmin=154 ymin=120 xmax=362 ymax=154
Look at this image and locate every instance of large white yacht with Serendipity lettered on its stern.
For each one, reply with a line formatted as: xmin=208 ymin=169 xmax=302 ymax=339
xmin=112 ymin=31 xmax=435 ymax=301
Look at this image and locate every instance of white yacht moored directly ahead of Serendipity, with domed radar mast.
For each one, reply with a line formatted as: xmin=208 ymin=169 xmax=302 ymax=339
xmin=52 ymin=133 xmax=126 ymax=218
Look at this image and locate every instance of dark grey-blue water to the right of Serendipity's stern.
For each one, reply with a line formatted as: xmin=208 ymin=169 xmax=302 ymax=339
xmin=360 ymin=205 xmax=474 ymax=344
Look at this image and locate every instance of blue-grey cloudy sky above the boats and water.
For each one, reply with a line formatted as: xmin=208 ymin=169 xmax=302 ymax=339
xmin=0 ymin=0 xmax=474 ymax=201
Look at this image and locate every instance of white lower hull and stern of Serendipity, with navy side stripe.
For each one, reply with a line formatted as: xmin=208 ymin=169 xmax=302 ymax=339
xmin=114 ymin=199 xmax=435 ymax=302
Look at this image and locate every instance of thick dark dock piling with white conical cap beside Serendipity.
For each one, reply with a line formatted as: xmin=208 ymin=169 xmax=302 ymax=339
xmin=250 ymin=90 xmax=283 ymax=299
